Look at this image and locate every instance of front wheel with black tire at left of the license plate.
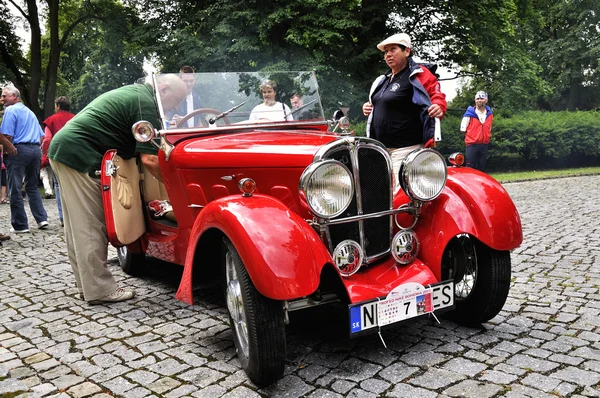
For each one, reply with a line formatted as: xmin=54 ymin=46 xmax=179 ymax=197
xmin=223 ymin=240 xmax=286 ymax=387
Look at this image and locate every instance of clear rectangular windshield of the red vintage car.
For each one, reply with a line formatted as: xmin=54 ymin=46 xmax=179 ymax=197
xmin=139 ymin=72 xmax=325 ymax=129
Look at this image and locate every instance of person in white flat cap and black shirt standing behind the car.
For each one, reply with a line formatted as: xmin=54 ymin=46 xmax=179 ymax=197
xmin=363 ymin=33 xmax=447 ymax=191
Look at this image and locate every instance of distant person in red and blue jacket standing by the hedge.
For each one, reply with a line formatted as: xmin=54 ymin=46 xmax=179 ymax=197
xmin=460 ymin=91 xmax=494 ymax=171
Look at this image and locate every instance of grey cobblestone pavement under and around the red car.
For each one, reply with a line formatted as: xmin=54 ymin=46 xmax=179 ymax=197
xmin=0 ymin=176 xmax=600 ymax=398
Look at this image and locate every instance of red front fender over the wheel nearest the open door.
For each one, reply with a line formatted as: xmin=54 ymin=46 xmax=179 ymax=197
xmin=176 ymin=194 xmax=333 ymax=305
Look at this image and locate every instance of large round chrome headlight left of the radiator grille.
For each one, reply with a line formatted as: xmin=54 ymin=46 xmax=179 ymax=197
xmin=299 ymin=159 xmax=354 ymax=218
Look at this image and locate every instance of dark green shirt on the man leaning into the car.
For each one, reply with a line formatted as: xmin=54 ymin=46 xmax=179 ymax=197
xmin=48 ymin=84 xmax=160 ymax=175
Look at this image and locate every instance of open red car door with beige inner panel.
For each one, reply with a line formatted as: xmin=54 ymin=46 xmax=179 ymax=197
xmin=100 ymin=150 xmax=146 ymax=247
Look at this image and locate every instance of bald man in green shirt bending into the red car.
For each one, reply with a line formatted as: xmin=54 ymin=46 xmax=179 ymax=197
xmin=48 ymin=74 xmax=187 ymax=304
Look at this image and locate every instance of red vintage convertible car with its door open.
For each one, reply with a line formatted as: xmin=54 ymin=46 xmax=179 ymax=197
xmin=101 ymin=71 xmax=522 ymax=385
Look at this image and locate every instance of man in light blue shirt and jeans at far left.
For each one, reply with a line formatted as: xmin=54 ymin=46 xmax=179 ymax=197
xmin=0 ymin=86 xmax=48 ymax=234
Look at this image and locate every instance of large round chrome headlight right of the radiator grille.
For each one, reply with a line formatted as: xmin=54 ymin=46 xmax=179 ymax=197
xmin=399 ymin=149 xmax=448 ymax=201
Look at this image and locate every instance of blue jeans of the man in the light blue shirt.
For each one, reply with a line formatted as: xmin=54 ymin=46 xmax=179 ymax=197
xmin=4 ymin=144 xmax=48 ymax=230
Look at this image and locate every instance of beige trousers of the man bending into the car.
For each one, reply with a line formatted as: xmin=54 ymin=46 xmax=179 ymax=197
xmin=50 ymin=160 xmax=118 ymax=301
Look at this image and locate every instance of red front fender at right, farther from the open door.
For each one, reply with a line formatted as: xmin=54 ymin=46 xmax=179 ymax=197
xmin=415 ymin=168 xmax=523 ymax=278
